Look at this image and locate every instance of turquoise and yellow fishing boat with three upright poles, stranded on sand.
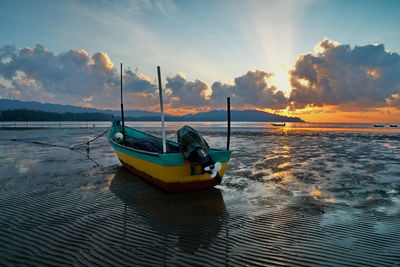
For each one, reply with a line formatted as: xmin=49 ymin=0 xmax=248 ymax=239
xmin=108 ymin=64 xmax=231 ymax=192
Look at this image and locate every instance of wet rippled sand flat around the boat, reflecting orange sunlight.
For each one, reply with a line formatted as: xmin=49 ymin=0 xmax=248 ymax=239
xmin=0 ymin=127 xmax=400 ymax=266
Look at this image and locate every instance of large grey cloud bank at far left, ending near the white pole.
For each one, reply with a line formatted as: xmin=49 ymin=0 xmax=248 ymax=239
xmin=0 ymin=45 xmax=159 ymax=106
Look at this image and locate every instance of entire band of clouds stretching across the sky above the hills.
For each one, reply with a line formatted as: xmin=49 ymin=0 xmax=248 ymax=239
xmin=5 ymin=38 xmax=400 ymax=115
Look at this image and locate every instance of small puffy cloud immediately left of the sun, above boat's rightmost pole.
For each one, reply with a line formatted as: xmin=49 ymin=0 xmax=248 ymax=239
xmin=211 ymin=70 xmax=288 ymax=109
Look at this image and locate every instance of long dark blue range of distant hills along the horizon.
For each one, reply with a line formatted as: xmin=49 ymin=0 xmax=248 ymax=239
xmin=0 ymin=99 xmax=304 ymax=122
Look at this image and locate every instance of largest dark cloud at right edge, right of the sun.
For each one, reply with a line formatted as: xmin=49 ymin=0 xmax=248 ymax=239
xmin=290 ymin=38 xmax=400 ymax=110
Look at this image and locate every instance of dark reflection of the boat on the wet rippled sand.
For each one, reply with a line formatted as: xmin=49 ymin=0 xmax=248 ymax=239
xmin=110 ymin=167 xmax=227 ymax=253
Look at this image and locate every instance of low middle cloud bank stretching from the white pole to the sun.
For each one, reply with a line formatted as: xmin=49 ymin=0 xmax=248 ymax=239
xmin=166 ymin=70 xmax=289 ymax=109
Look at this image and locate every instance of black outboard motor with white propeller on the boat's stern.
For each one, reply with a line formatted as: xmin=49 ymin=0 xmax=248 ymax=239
xmin=178 ymin=125 xmax=221 ymax=179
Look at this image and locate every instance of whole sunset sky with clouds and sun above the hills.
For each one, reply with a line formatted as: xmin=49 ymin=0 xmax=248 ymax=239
xmin=0 ymin=0 xmax=400 ymax=122
